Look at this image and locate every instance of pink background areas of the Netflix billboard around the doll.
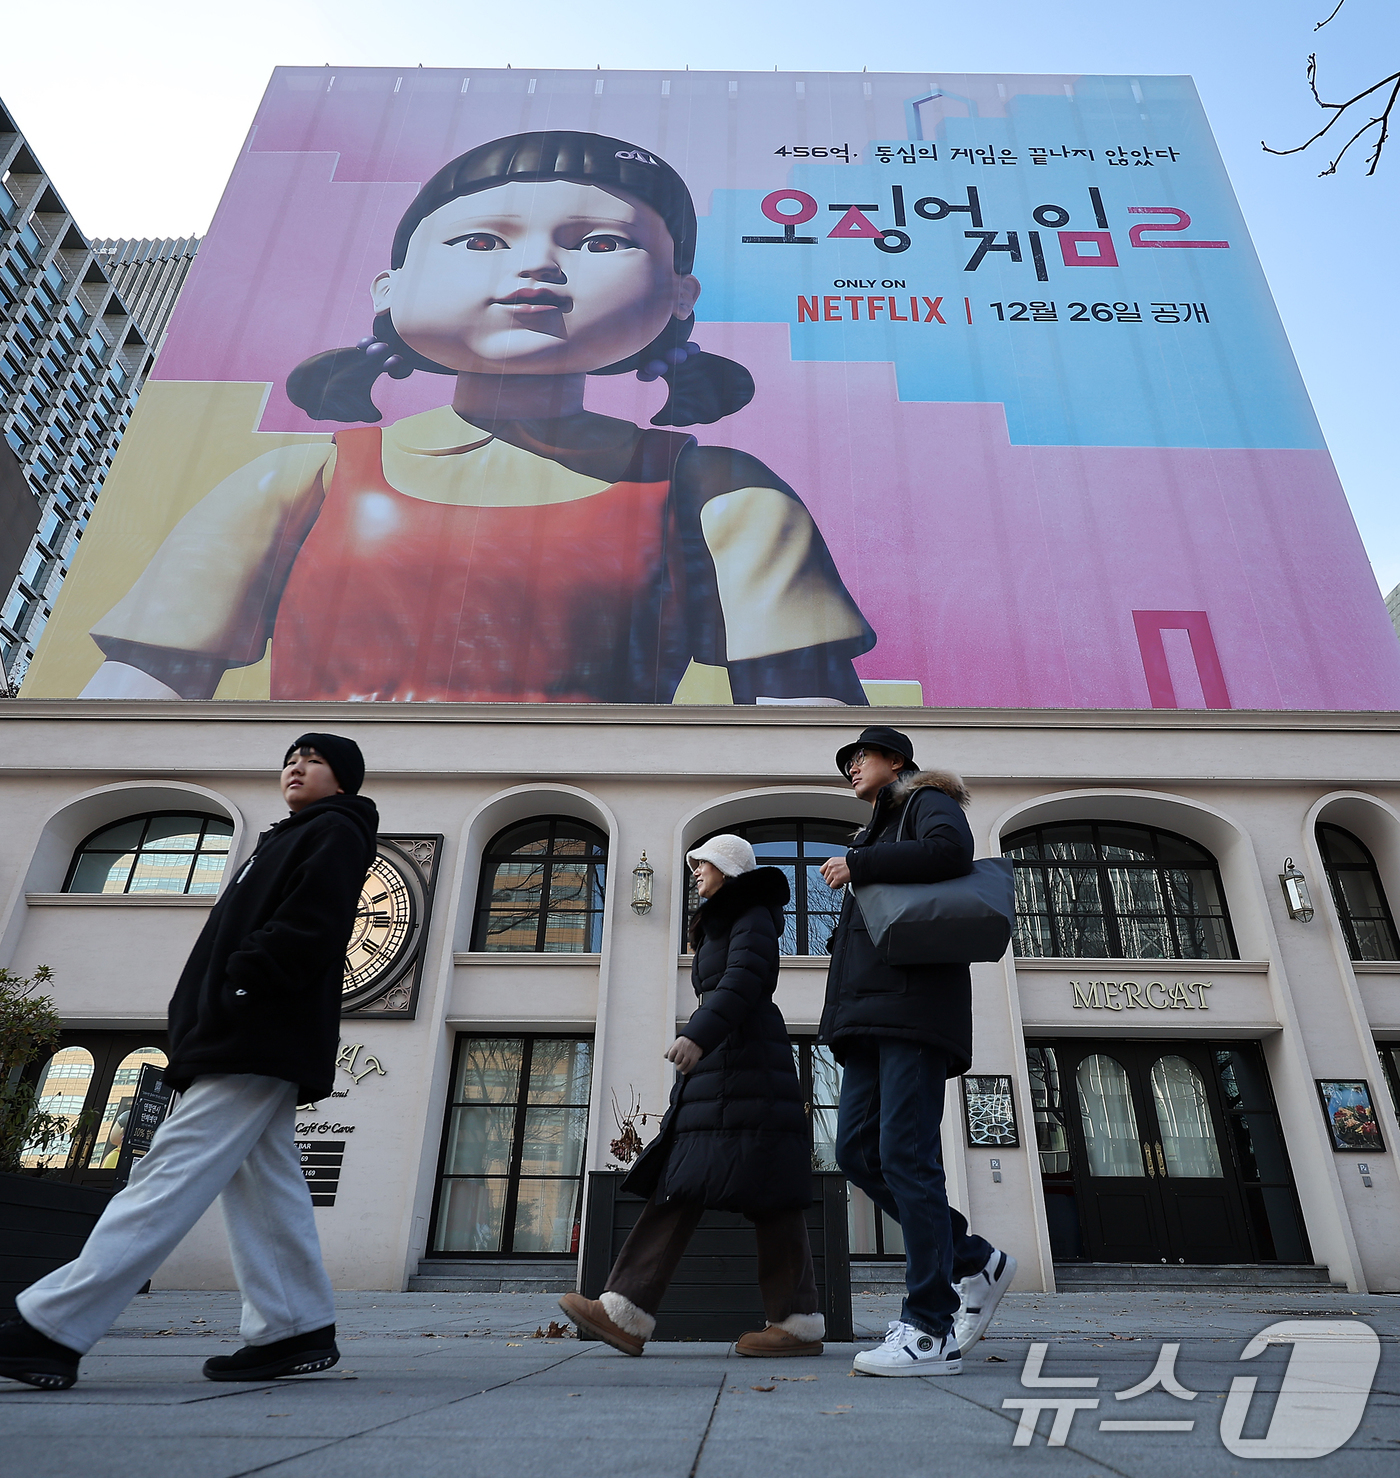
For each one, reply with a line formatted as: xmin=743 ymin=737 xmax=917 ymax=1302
xmin=133 ymin=69 xmax=1400 ymax=709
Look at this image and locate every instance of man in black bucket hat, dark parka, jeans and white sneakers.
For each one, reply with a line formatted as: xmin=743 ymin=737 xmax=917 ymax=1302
xmin=818 ymin=726 xmax=1016 ymax=1376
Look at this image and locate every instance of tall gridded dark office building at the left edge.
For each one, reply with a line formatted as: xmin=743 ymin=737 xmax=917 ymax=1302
xmin=0 ymin=105 xmax=169 ymax=692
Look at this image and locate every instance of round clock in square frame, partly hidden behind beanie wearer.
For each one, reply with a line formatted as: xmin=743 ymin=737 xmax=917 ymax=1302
xmin=340 ymin=837 xmax=442 ymax=1020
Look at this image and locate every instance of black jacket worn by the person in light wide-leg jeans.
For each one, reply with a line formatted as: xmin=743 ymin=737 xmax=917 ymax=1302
xmin=163 ymin=795 xmax=378 ymax=1103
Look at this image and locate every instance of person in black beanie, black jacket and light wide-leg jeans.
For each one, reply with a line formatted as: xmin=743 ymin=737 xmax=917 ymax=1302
xmin=0 ymin=733 xmax=378 ymax=1391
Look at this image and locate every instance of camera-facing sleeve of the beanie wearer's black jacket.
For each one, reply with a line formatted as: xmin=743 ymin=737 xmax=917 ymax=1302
xmin=226 ymin=816 xmax=368 ymax=992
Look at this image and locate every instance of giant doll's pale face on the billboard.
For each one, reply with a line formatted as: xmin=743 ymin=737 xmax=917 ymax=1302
xmin=374 ymin=180 xmax=699 ymax=374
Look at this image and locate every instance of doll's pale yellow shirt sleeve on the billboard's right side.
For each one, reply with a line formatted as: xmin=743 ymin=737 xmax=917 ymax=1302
xmin=699 ymin=488 xmax=871 ymax=662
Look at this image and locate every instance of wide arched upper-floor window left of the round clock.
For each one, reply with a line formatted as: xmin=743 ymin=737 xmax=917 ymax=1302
xmin=64 ymin=811 xmax=234 ymax=894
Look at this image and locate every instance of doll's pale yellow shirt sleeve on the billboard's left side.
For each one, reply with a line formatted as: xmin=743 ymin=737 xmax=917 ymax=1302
xmin=92 ymin=442 xmax=336 ymax=667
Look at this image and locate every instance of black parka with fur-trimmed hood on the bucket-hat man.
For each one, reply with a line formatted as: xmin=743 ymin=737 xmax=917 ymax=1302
xmin=818 ymin=770 xmax=973 ymax=1075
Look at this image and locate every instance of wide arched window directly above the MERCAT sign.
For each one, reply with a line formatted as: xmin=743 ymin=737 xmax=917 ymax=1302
xmin=1001 ymin=822 xmax=1237 ymax=959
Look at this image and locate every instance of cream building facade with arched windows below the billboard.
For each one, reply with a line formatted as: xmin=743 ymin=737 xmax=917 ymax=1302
xmin=0 ymin=701 xmax=1400 ymax=1292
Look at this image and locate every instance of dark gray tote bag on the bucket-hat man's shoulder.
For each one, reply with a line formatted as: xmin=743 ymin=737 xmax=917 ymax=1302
xmin=852 ymin=807 xmax=1016 ymax=965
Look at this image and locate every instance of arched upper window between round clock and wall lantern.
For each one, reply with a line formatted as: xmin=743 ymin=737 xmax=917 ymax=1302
xmin=472 ymin=816 xmax=608 ymax=955
